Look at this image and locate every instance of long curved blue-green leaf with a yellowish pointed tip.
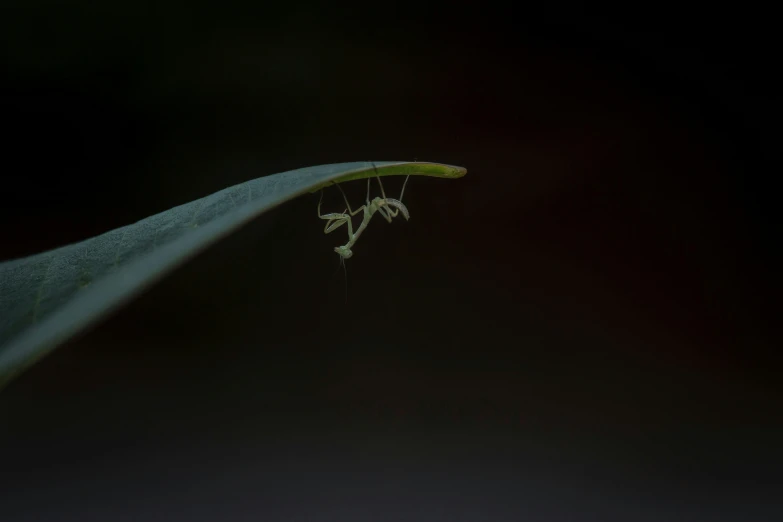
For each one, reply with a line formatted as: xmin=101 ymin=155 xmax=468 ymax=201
xmin=0 ymin=162 xmax=466 ymax=388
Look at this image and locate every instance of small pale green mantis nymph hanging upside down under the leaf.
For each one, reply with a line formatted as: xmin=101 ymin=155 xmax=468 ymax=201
xmin=318 ymin=164 xmax=411 ymax=260
